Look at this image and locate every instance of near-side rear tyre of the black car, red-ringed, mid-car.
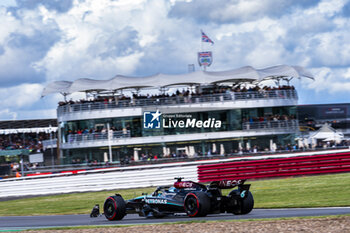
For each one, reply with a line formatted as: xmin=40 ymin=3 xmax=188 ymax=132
xmin=184 ymin=192 xmax=210 ymax=217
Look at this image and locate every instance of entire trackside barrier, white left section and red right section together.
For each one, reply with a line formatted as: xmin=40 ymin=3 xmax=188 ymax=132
xmin=0 ymin=149 xmax=350 ymax=199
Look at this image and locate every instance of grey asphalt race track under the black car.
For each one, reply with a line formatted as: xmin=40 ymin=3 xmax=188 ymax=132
xmin=0 ymin=207 xmax=350 ymax=231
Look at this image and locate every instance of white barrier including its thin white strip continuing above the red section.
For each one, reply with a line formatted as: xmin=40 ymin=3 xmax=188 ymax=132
xmin=0 ymin=149 xmax=350 ymax=199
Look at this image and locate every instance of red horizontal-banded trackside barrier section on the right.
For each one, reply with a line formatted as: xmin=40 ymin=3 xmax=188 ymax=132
xmin=198 ymin=152 xmax=350 ymax=182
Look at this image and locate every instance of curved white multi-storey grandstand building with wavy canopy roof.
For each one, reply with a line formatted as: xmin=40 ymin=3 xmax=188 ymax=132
xmin=42 ymin=65 xmax=313 ymax=164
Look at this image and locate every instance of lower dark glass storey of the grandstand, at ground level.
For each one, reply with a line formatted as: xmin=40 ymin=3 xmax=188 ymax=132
xmin=62 ymin=134 xmax=295 ymax=164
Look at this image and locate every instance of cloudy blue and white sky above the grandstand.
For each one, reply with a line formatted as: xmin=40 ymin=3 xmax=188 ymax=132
xmin=0 ymin=0 xmax=350 ymax=120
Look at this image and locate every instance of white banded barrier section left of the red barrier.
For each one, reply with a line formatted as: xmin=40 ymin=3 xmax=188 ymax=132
xmin=0 ymin=165 xmax=197 ymax=198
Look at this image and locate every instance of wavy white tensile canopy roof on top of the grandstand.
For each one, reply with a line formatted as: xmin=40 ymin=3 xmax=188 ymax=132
xmin=42 ymin=65 xmax=314 ymax=96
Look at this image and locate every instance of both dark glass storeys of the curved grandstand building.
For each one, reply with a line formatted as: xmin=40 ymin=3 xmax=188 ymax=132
xmin=59 ymin=106 xmax=297 ymax=164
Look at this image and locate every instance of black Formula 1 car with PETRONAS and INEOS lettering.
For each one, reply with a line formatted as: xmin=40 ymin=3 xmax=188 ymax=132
xmin=92 ymin=178 xmax=254 ymax=221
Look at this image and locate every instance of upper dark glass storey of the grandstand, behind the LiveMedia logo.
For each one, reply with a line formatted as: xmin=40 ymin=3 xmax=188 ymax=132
xmin=59 ymin=106 xmax=296 ymax=143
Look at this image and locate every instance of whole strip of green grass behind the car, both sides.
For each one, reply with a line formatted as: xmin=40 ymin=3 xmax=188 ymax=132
xmin=0 ymin=173 xmax=350 ymax=216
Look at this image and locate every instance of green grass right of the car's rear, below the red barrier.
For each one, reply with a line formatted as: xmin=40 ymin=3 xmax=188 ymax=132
xmin=245 ymin=173 xmax=350 ymax=208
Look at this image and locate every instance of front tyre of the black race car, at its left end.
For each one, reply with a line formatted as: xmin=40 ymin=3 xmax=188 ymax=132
xmin=103 ymin=196 xmax=126 ymax=221
